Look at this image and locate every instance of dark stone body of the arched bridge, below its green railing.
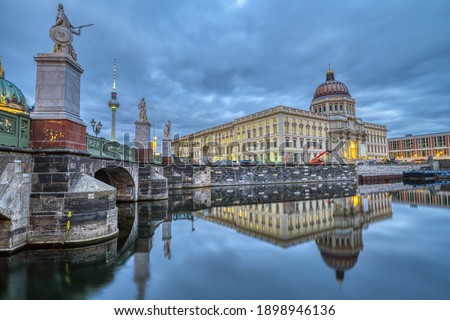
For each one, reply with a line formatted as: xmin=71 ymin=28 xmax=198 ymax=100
xmin=0 ymin=147 xmax=168 ymax=251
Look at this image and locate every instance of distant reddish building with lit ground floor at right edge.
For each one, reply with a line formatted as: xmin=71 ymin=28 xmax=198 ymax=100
xmin=388 ymin=132 xmax=450 ymax=161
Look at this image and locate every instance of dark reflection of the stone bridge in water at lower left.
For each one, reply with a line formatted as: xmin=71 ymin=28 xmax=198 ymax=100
xmin=0 ymin=201 xmax=167 ymax=300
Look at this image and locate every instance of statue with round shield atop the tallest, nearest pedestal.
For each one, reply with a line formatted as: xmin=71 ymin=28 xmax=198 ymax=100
xmin=49 ymin=3 xmax=93 ymax=61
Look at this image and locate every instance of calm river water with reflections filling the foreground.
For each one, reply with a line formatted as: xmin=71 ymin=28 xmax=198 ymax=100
xmin=0 ymin=183 xmax=450 ymax=300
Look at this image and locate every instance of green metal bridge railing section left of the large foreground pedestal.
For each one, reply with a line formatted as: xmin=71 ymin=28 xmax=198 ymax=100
xmin=0 ymin=110 xmax=30 ymax=148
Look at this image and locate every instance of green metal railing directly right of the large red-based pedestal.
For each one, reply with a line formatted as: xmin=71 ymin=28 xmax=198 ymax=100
xmin=86 ymin=135 xmax=136 ymax=161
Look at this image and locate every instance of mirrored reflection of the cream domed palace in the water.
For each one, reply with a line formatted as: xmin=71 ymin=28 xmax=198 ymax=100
xmin=193 ymin=189 xmax=392 ymax=281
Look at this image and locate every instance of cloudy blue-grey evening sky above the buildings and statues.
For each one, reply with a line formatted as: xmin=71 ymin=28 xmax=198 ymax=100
xmin=0 ymin=0 xmax=450 ymax=138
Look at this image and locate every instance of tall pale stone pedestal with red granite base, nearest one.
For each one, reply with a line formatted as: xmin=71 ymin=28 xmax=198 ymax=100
xmin=30 ymin=53 xmax=86 ymax=151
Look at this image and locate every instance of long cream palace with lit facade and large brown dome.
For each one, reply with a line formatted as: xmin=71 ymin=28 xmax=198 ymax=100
xmin=172 ymin=69 xmax=388 ymax=163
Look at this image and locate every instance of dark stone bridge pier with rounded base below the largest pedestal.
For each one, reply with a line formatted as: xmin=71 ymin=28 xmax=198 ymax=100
xmin=28 ymin=152 xmax=118 ymax=246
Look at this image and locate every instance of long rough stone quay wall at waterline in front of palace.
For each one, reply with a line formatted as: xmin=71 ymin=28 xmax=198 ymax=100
xmin=164 ymin=165 xmax=357 ymax=189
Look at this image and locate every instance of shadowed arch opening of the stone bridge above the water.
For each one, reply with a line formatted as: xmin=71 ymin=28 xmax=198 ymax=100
xmin=94 ymin=166 xmax=136 ymax=201
